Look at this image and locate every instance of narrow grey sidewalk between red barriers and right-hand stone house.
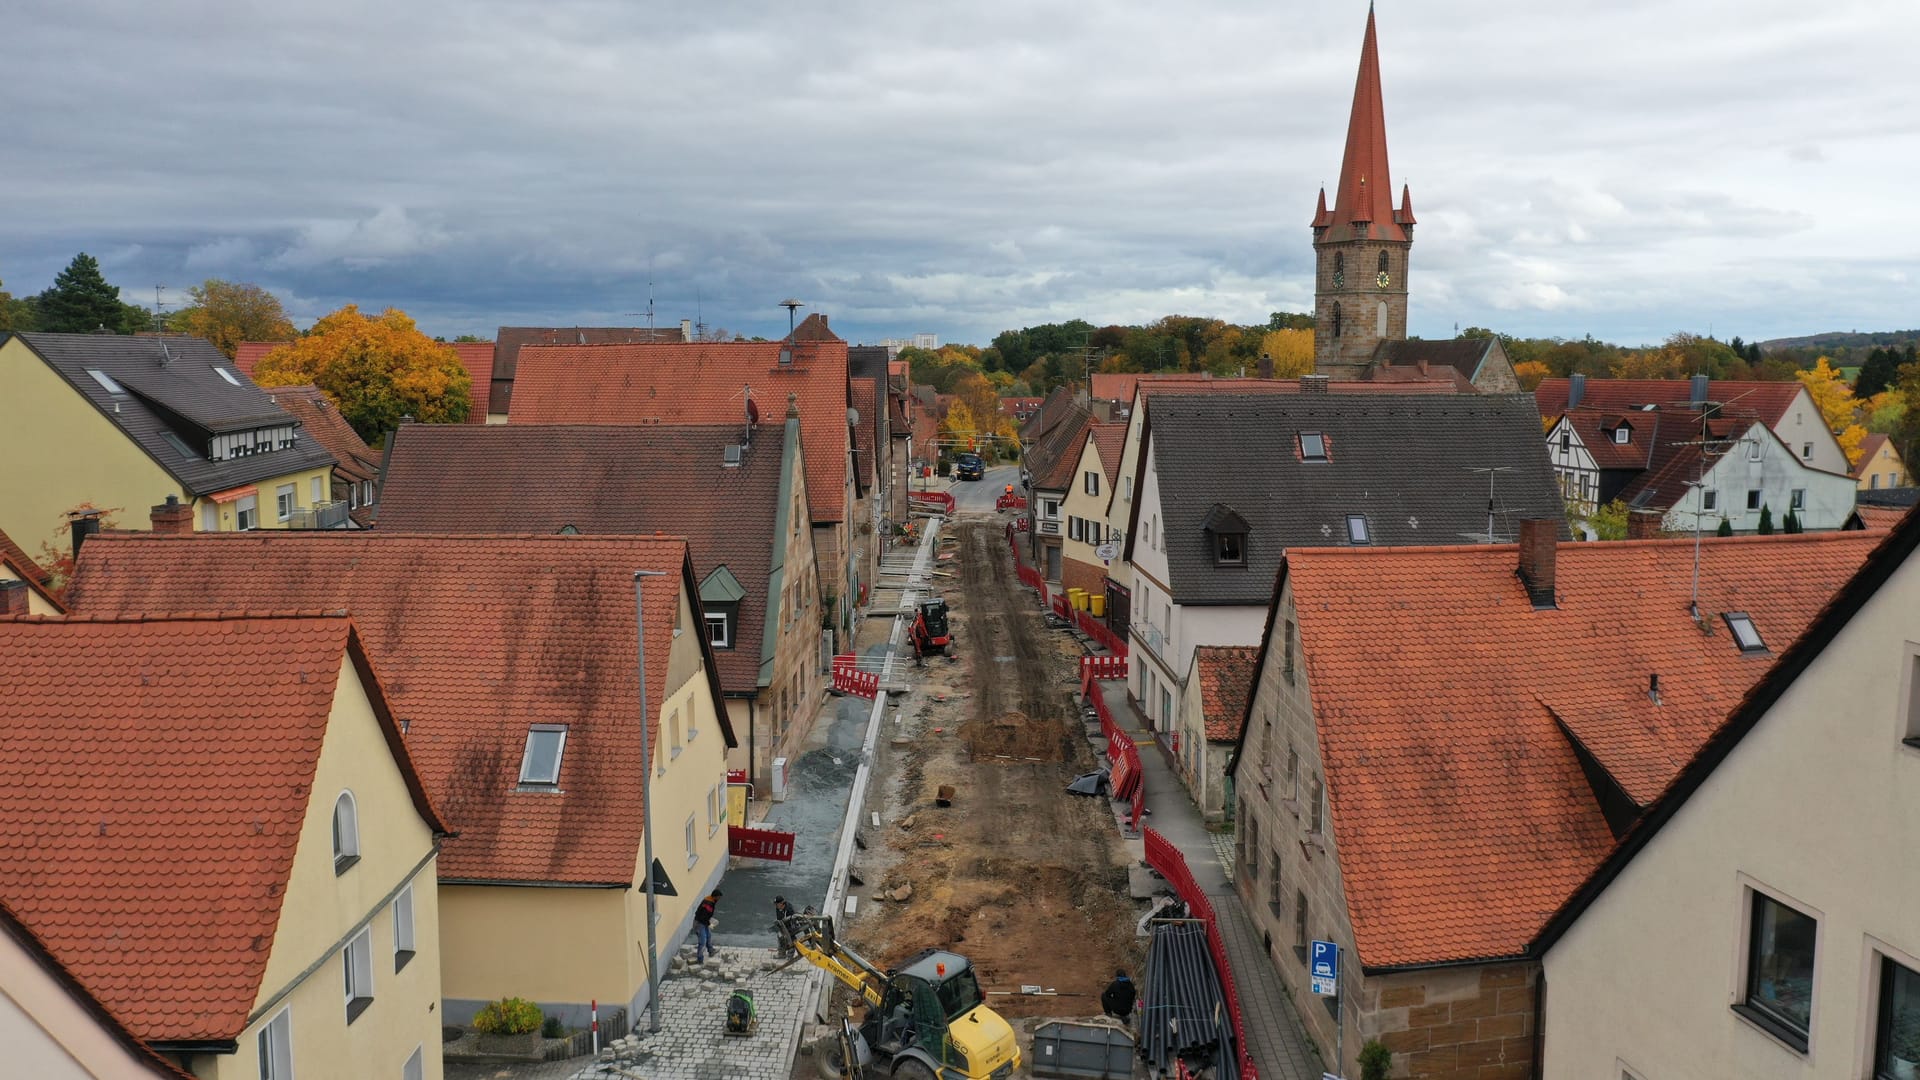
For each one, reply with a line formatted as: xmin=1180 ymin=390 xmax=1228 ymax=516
xmin=1094 ymin=678 xmax=1321 ymax=1080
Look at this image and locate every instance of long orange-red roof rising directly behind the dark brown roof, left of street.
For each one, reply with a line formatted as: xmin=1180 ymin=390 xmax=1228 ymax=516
xmin=511 ymin=338 xmax=852 ymax=523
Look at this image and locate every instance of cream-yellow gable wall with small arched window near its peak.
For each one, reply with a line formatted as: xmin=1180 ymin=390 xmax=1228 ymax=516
xmin=194 ymin=663 xmax=442 ymax=1080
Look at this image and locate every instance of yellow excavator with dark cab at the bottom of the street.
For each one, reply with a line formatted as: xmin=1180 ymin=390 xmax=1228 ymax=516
xmin=783 ymin=913 xmax=1020 ymax=1080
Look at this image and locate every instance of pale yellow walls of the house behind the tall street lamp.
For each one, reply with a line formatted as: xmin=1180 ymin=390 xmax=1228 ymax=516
xmin=440 ymin=582 xmax=726 ymax=1022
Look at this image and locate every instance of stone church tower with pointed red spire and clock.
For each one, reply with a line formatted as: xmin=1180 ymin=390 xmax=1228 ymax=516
xmin=1313 ymin=8 xmax=1413 ymax=379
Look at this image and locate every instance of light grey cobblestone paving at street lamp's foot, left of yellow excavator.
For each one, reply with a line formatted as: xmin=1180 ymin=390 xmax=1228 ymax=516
xmin=572 ymin=945 xmax=812 ymax=1080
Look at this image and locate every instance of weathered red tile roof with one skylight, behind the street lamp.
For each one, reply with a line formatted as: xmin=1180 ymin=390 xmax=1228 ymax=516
xmin=71 ymin=528 xmax=733 ymax=884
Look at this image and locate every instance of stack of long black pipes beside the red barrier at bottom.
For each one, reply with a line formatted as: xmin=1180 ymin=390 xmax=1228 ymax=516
xmin=1140 ymin=920 xmax=1240 ymax=1080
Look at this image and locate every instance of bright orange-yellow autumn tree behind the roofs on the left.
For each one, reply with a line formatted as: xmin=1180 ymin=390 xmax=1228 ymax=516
xmin=253 ymin=304 xmax=472 ymax=442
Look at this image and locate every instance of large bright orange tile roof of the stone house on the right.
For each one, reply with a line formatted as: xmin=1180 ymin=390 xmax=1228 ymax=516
xmin=1274 ymin=532 xmax=1884 ymax=969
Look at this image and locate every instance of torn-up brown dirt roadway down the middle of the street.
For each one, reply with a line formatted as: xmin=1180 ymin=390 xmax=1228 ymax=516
xmin=849 ymin=515 xmax=1140 ymax=1019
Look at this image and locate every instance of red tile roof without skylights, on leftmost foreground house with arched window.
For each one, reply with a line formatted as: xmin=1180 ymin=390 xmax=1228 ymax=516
xmin=0 ymin=614 xmax=440 ymax=1042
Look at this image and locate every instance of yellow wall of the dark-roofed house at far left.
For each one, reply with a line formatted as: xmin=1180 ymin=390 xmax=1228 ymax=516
xmin=0 ymin=338 xmax=332 ymax=555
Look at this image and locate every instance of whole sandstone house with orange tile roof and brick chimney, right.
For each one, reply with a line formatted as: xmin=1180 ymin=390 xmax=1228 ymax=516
xmin=1227 ymin=515 xmax=1880 ymax=1080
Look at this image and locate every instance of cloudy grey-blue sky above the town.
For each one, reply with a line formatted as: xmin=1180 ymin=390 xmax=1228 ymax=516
xmin=0 ymin=0 xmax=1920 ymax=344
